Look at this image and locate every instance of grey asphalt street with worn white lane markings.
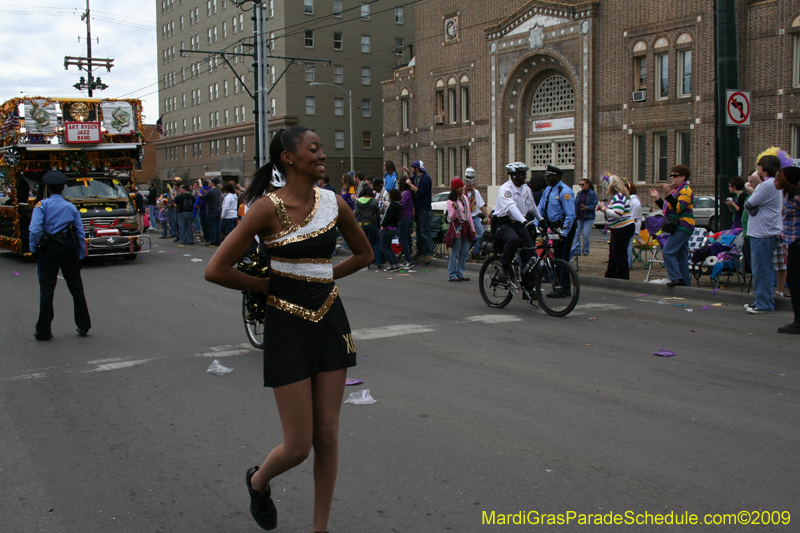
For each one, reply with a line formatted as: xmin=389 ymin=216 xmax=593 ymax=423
xmin=0 ymin=239 xmax=800 ymax=533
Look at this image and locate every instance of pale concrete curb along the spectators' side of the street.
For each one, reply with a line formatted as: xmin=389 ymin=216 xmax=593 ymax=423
xmin=336 ymin=248 xmax=792 ymax=312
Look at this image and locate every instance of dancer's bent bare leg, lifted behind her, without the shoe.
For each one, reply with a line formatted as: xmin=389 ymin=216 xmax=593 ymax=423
xmin=250 ymin=378 xmax=312 ymax=492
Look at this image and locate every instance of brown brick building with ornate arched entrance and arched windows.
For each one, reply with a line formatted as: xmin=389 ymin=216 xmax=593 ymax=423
xmin=383 ymin=0 xmax=800 ymax=208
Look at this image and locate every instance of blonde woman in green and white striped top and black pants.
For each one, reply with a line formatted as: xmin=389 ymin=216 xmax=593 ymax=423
xmin=597 ymin=176 xmax=634 ymax=279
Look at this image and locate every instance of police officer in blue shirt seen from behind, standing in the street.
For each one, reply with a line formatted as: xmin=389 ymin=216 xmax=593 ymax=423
xmin=29 ymin=170 xmax=92 ymax=341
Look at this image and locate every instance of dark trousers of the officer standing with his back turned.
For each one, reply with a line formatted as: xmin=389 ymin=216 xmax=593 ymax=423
xmin=36 ymin=239 xmax=92 ymax=337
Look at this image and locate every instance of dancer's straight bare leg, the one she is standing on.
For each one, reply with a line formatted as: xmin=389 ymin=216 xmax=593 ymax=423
xmin=311 ymin=369 xmax=347 ymax=531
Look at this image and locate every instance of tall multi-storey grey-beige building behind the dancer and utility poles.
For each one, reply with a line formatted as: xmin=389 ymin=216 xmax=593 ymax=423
xmin=155 ymin=0 xmax=414 ymax=187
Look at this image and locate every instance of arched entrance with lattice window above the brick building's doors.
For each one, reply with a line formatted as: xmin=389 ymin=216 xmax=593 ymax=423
xmin=522 ymin=70 xmax=575 ymax=185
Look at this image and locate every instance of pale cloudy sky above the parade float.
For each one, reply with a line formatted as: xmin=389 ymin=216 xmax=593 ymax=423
xmin=0 ymin=0 xmax=158 ymax=124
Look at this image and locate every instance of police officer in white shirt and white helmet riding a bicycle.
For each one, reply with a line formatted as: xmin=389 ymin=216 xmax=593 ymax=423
xmin=494 ymin=163 xmax=542 ymax=282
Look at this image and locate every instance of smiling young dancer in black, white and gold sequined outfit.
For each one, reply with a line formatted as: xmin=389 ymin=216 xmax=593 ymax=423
xmin=206 ymin=126 xmax=373 ymax=532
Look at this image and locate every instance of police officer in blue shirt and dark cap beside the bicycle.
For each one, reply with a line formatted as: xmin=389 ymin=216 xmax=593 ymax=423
xmin=539 ymin=165 xmax=576 ymax=296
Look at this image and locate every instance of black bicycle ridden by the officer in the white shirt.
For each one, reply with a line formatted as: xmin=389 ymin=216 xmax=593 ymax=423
xmin=479 ymin=225 xmax=581 ymax=317
